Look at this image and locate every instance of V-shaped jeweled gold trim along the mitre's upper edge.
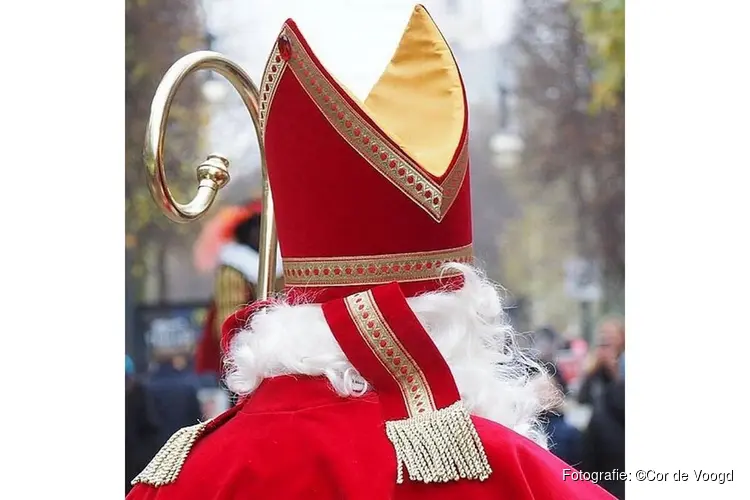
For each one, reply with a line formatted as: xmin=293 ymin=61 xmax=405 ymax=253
xmin=276 ymin=27 xmax=468 ymax=222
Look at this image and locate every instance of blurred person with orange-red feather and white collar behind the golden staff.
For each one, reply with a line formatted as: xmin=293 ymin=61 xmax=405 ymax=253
xmin=194 ymin=200 xmax=282 ymax=381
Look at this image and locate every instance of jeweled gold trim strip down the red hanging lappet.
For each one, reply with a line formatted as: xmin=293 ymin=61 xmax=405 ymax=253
xmin=344 ymin=291 xmax=435 ymax=416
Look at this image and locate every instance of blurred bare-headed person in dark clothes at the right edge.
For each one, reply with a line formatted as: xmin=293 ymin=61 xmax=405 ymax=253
xmin=578 ymin=317 xmax=625 ymax=408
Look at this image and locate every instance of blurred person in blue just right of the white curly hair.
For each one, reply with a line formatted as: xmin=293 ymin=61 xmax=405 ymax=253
xmin=540 ymin=375 xmax=582 ymax=467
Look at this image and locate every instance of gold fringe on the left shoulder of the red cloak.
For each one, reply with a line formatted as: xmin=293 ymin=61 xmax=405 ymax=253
xmin=131 ymin=422 xmax=208 ymax=487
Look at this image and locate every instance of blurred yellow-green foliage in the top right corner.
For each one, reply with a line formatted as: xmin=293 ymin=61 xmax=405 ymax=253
xmin=575 ymin=0 xmax=625 ymax=111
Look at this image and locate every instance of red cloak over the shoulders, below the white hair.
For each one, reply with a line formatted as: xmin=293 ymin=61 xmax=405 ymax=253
xmin=127 ymin=376 xmax=613 ymax=500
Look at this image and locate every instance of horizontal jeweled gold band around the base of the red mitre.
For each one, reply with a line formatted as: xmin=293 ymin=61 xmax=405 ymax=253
xmin=284 ymin=245 xmax=473 ymax=287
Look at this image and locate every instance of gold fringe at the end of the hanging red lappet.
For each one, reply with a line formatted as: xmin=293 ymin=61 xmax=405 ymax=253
xmin=386 ymin=401 xmax=492 ymax=484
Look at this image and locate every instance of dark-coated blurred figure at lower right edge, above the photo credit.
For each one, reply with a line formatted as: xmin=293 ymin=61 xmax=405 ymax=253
xmin=581 ymin=379 xmax=625 ymax=500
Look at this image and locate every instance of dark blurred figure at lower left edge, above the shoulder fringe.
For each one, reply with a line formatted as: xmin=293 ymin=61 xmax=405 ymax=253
xmin=125 ymin=355 xmax=161 ymax=494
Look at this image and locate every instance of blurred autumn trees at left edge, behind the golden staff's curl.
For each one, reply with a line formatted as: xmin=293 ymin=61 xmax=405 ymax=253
xmin=125 ymin=0 xmax=207 ymax=301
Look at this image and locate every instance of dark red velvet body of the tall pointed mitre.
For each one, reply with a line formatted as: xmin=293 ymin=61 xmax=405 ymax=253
xmin=264 ymin=20 xmax=472 ymax=302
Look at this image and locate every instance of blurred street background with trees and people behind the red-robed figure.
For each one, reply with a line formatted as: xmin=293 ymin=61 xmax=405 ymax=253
xmin=125 ymin=0 xmax=625 ymax=498
